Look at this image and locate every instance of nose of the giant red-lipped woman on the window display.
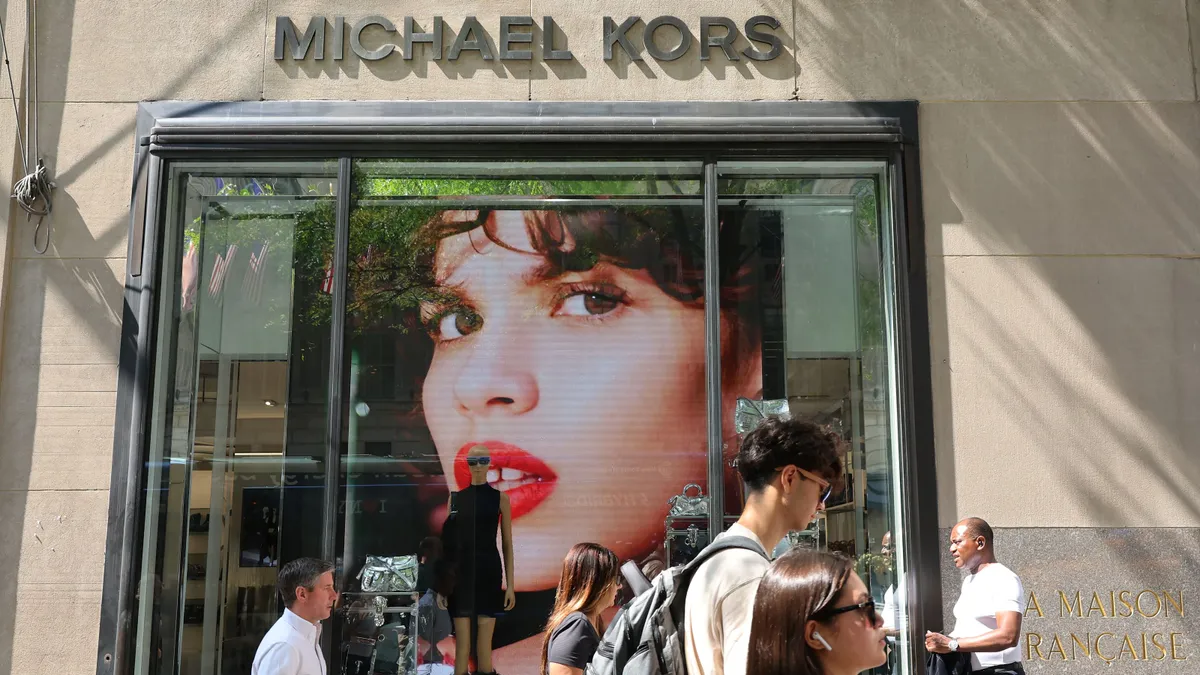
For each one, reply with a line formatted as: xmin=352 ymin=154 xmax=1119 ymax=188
xmin=454 ymin=328 xmax=538 ymax=416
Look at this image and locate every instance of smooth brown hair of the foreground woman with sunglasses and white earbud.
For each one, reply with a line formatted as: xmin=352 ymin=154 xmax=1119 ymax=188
xmin=746 ymin=549 xmax=854 ymax=675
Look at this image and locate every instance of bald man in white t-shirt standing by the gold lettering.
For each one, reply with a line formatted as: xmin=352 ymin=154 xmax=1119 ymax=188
xmin=925 ymin=518 xmax=1025 ymax=675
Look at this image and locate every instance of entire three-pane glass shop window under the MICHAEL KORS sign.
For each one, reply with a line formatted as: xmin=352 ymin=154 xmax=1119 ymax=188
xmin=137 ymin=156 xmax=908 ymax=675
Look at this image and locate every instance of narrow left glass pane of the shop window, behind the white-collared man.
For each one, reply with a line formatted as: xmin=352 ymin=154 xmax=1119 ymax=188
xmin=136 ymin=162 xmax=336 ymax=674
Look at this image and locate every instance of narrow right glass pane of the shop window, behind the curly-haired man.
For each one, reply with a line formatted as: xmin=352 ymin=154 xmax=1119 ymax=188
xmin=718 ymin=162 xmax=907 ymax=662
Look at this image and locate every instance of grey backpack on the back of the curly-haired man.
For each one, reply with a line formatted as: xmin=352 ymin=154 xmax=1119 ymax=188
xmin=587 ymin=537 xmax=768 ymax=675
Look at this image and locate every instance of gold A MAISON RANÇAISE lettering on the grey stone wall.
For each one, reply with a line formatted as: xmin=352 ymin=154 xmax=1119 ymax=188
xmin=1024 ymin=589 xmax=1189 ymax=664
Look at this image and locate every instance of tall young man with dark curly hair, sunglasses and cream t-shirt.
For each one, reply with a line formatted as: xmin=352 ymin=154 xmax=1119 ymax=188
xmin=683 ymin=417 xmax=841 ymax=675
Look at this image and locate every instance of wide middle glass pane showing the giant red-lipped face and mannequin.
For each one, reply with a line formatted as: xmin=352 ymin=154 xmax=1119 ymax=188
xmin=342 ymin=161 xmax=707 ymax=673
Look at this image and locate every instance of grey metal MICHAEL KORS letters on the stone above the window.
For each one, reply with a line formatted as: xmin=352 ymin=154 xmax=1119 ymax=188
xmin=275 ymin=16 xmax=784 ymax=61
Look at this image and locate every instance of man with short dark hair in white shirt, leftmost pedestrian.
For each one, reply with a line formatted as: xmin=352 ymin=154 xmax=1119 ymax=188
xmin=251 ymin=557 xmax=337 ymax=675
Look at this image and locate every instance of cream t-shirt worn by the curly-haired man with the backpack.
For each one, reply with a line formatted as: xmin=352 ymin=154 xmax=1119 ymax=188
xmin=683 ymin=524 xmax=770 ymax=675
